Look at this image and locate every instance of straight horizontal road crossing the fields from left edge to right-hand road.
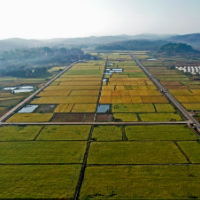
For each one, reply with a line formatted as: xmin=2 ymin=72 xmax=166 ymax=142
xmin=1 ymin=121 xmax=188 ymax=125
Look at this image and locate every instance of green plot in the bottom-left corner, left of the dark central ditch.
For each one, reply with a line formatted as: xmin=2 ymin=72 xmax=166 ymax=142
xmin=0 ymin=165 xmax=81 ymax=199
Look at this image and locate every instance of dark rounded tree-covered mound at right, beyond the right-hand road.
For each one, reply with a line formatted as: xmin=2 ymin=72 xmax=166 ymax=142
xmin=158 ymin=43 xmax=199 ymax=55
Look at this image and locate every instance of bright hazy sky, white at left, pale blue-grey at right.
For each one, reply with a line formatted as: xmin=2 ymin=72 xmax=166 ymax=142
xmin=0 ymin=0 xmax=200 ymax=39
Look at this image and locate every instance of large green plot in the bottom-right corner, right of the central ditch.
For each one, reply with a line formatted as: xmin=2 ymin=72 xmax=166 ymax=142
xmin=80 ymin=165 xmax=200 ymax=200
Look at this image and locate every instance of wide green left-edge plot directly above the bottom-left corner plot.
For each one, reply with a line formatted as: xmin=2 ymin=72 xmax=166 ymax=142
xmin=0 ymin=141 xmax=86 ymax=164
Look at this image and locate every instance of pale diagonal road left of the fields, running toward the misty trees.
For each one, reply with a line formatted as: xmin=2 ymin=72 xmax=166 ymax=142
xmin=0 ymin=62 xmax=76 ymax=123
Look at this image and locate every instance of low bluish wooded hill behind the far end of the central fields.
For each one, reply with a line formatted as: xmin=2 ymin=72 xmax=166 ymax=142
xmin=96 ymin=40 xmax=167 ymax=51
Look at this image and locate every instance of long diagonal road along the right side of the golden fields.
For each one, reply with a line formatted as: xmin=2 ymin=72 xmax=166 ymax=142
xmin=129 ymin=52 xmax=200 ymax=129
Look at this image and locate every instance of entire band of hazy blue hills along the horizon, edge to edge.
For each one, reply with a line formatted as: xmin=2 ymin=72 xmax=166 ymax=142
xmin=0 ymin=33 xmax=200 ymax=52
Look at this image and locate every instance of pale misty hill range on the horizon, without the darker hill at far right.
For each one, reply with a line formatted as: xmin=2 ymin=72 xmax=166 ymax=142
xmin=0 ymin=34 xmax=174 ymax=51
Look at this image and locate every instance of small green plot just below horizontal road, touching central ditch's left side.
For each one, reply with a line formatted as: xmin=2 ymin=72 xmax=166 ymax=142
xmin=37 ymin=125 xmax=91 ymax=140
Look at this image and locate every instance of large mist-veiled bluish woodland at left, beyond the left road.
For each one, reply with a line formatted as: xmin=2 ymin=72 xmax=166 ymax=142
xmin=0 ymin=47 xmax=92 ymax=77
